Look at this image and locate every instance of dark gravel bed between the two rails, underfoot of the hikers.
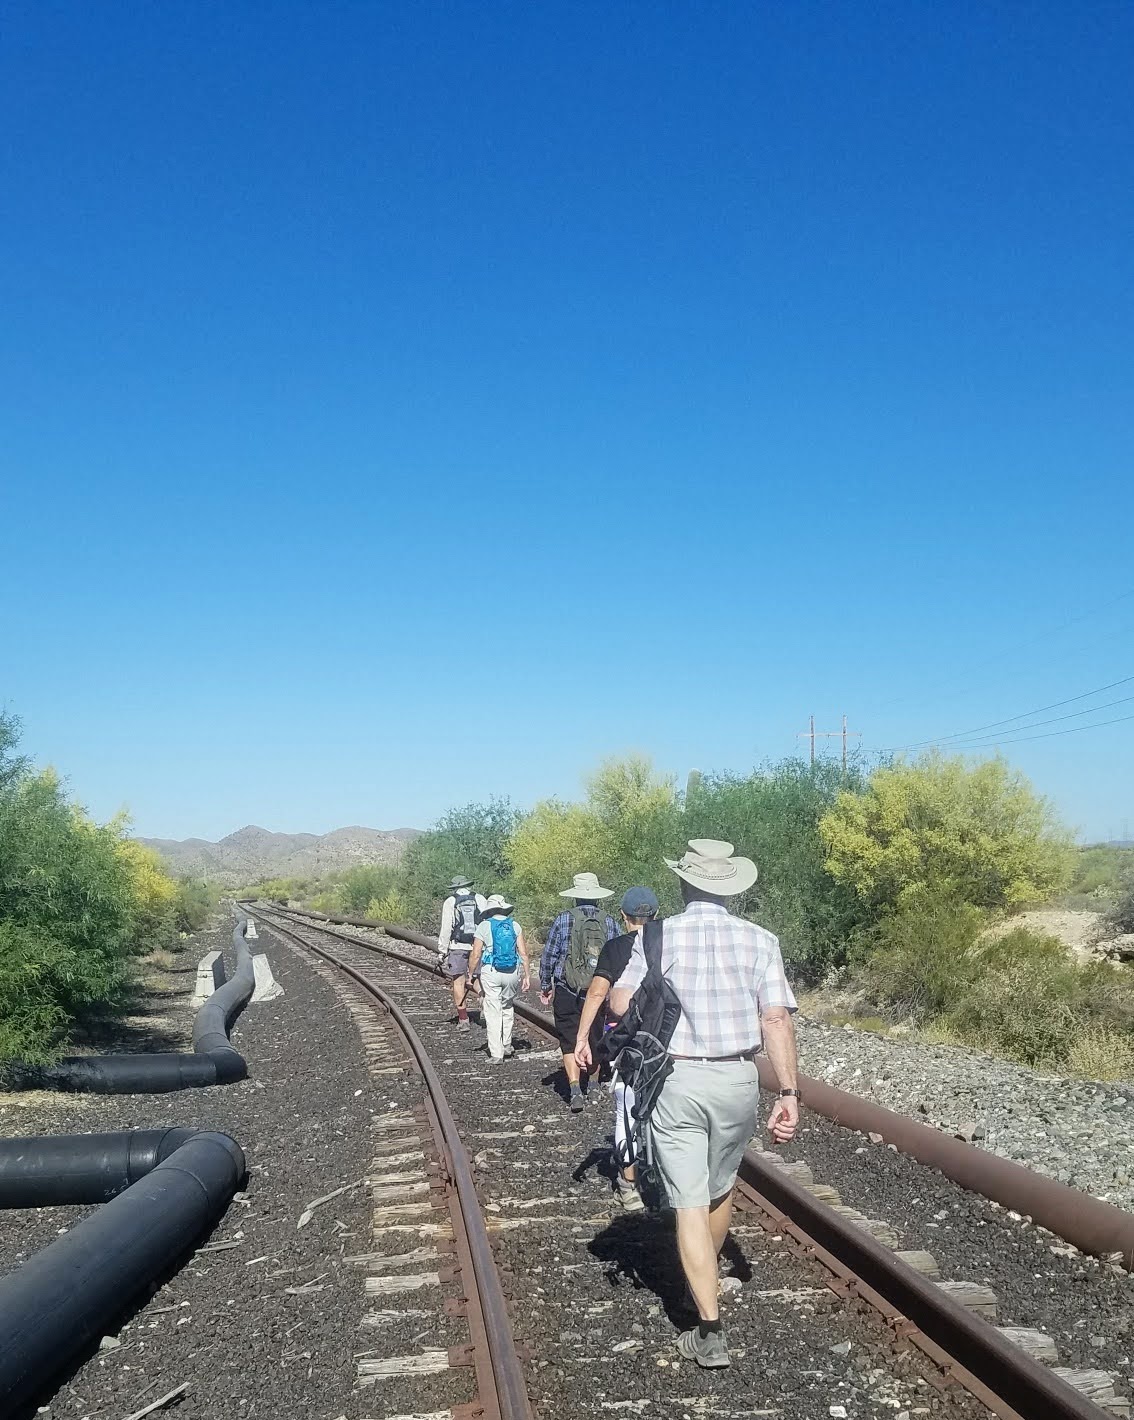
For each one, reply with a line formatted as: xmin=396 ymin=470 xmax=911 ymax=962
xmin=261 ymin=923 xmax=984 ymax=1420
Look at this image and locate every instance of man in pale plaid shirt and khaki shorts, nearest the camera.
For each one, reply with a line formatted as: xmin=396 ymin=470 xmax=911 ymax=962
xmin=616 ymin=838 xmax=799 ymax=1367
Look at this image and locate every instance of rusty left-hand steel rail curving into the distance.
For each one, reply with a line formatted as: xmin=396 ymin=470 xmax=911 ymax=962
xmin=261 ymin=913 xmax=532 ymax=1420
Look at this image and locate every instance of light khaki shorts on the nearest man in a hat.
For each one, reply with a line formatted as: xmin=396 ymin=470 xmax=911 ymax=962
xmin=650 ymin=1061 xmax=759 ymax=1208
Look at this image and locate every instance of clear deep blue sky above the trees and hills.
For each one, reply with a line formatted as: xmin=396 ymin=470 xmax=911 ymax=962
xmin=0 ymin=0 xmax=1134 ymax=836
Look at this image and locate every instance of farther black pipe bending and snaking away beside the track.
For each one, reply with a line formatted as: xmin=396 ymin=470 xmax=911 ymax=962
xmin=4 ymin=917 xmax=255 ymax=1095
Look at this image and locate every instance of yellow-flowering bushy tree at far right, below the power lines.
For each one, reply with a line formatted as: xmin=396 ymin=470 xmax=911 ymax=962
xmin=819 ymin=751 xmax=1074 ymax=917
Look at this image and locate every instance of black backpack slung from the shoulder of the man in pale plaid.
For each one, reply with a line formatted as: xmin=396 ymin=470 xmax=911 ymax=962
xmin=603 ymin=922 xmax=681 ymax=1191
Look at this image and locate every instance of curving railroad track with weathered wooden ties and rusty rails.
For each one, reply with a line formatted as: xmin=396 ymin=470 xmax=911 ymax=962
xmin=253 ymin=905 xmax=1125 ymax=1420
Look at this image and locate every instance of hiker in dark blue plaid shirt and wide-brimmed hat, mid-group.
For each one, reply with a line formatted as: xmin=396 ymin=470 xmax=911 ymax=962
xmin=539 ymin=873 xmax=619 ymax=1115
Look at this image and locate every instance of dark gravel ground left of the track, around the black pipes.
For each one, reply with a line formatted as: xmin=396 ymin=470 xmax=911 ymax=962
xmin=0 ymin=919 xmax=386 ymax=1420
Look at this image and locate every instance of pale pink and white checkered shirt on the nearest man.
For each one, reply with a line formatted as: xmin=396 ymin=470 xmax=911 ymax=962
xmin=615 ymin=902 xmax=796 ymax=1056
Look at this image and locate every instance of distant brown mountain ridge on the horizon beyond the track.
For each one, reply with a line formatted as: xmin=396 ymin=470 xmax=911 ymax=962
xmin=139 ymin=824 xmax=420 ymax=888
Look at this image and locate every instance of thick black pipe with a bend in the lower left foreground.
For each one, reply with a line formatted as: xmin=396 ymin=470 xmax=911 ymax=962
xmin=0 ymin=1130 xmax=244 ymax=1414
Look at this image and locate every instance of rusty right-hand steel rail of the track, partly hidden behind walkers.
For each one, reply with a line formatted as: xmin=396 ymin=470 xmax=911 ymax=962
xmin=259 ymin=909 xmax=1118 ymax=1420
